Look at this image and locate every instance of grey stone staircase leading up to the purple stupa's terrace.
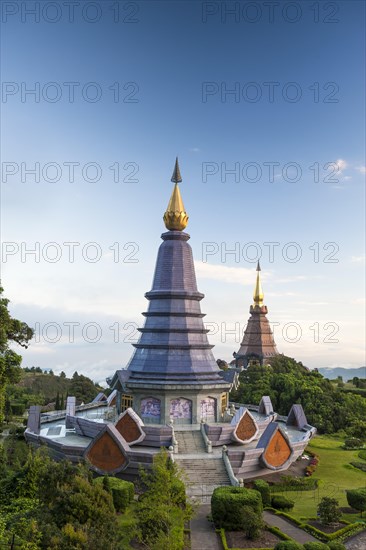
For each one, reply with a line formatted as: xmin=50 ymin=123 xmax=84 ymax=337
xmin=174 ymin=430 xmax=231 ymax=503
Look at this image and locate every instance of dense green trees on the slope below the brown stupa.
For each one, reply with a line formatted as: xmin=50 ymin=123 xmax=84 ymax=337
xmin=230 ymin=355 xmax=366 ymax=433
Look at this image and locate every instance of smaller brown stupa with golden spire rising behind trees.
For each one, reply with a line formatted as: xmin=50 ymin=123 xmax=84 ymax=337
xmin=233 ymin=262 xmax=278 ymax=368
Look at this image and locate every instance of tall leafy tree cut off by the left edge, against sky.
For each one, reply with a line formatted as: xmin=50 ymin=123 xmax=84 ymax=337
xmin=0 ymin=287 xmax=33 ymax=422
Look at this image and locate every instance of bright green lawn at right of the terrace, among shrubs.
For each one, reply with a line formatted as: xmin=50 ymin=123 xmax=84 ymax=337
xmin=272 ymin=435 xmax=366 ymax=521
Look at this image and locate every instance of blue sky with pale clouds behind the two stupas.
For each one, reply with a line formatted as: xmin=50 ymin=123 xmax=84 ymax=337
xmin=1 ymin=0 xmax=365 ymax=386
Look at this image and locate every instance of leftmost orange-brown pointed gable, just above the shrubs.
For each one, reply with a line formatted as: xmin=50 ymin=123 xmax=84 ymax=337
xmin=84 ymin=424 xmax=129 ymax=474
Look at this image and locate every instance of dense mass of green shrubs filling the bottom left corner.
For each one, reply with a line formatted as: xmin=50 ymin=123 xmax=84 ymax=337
xmin=0 ymin=449 xmax=119 ymax=550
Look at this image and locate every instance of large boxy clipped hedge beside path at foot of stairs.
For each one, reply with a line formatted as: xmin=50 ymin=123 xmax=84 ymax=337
xmin=211 ymin=487 xmax=263 ymax=535
